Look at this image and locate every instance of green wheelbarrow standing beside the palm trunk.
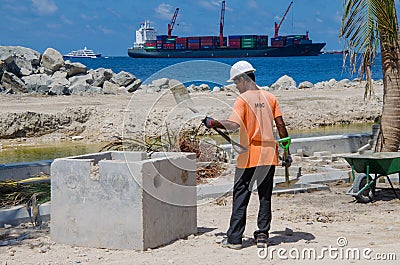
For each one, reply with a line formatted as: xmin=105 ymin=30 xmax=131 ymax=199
xmin=343 ymin=152 xmax=400 ymax=203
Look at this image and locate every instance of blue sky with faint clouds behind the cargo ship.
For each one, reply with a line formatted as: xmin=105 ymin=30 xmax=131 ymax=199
xmin=0 ymin=0 xmax=343 ymax=56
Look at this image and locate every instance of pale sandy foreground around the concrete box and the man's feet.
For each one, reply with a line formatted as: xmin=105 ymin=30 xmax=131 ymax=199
xmin=0 ymin=182 xmax=400 ymax=265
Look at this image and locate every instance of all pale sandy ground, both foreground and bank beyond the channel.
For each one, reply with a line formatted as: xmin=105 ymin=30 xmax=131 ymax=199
xmin=0 ymin=83 xmax=400 ymax=265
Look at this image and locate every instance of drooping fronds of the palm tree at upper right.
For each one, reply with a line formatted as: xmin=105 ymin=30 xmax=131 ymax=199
xmin=339 ymin=0 xmax=398 ymax=97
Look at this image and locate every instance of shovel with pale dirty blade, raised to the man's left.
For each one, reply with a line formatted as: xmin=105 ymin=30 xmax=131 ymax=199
xmin=171 ymin=84 xmax=247 ymax=154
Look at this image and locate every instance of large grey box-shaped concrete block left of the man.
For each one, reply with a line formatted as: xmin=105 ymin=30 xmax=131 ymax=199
xmin=50 ymin=152 xmax=197 ymax=250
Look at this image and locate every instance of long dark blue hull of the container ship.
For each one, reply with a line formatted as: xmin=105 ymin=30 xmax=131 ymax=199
xmin=128 ymin=43 xmax=325 ymax=58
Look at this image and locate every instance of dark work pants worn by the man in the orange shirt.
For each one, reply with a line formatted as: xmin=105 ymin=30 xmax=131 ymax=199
xmin=227 ymin=166 xmax=275 ymax=244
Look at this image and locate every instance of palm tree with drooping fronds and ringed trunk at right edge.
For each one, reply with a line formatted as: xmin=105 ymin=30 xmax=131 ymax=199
xmin=340 ymin=0 xmax=400 ymax=152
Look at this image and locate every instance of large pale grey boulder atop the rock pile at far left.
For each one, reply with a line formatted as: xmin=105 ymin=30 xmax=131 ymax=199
xmin=0 ymin=46 xmax=41 ymax=76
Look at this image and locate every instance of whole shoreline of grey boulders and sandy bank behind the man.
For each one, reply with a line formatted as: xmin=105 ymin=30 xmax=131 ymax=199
xmin=0 ymin=46 xmax=383 ymax=142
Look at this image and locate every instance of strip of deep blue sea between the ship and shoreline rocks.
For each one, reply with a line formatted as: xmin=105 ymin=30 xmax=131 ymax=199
xmin=72 ymin=54 xmax=382 ymax=87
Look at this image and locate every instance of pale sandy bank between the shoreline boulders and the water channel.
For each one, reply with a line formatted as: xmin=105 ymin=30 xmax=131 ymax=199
xmin=0 ymin=84 xmax=382 ymax=146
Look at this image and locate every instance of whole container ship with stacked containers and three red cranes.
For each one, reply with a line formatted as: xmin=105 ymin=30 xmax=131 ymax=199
xmin=128 ymin=1 xmax=326 ymax=58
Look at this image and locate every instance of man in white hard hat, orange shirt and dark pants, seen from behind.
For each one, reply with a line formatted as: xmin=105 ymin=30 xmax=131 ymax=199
xmin=203 ymin=61 xmax=292 ymax=249
